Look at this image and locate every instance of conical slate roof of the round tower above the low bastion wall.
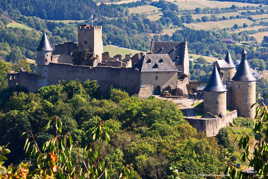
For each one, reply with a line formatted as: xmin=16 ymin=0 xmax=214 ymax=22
xmin=204 ymin=64 xmax=227 ymax=92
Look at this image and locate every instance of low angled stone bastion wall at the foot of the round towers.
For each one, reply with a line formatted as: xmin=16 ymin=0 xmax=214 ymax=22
xmin=185 ymin=110 xmax=237 ymax=137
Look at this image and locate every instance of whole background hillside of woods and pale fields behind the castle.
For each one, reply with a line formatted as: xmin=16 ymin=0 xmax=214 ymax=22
xmin=0 ymin=0 xmax=268 ymax=82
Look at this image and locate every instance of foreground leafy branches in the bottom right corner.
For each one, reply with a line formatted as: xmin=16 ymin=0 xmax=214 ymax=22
xmin=227 ymin=106 xmax=268 ymax=178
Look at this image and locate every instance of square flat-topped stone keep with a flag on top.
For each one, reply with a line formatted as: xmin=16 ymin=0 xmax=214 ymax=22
xmin=78 ymin=25 xmax=103 ymax=63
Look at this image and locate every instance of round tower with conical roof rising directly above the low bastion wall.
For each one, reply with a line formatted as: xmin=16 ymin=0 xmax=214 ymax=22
xmin=204 ymin=64 xmax=227 ymax=117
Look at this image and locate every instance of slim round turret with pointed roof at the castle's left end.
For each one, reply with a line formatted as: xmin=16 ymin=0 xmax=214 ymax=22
xmin=36 ymin=33 xmax=53 ymax=65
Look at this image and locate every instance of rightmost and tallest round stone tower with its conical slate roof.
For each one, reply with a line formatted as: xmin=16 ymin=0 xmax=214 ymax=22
xmin=232 ymin=50 xmax=256 ymax=118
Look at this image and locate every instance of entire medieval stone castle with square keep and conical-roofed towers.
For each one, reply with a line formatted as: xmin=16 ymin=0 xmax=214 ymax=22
xmin=8 ymin=25 xmax=256 ymax=136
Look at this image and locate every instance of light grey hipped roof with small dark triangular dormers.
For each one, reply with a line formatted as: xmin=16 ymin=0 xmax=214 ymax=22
xmin=141 ymin=54 xmax=178 ymax=72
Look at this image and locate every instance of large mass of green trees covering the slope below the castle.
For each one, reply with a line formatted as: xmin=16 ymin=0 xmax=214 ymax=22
xmin=0 ymin=81 xmax=228 ymax=178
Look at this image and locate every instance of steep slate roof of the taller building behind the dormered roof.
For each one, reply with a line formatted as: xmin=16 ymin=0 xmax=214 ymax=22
xmin=151 ymin=41 xmax=188 ymax=65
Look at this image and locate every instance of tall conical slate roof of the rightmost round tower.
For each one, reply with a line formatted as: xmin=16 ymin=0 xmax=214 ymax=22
xmin=233 ymin=50 xmax=256 ymax=82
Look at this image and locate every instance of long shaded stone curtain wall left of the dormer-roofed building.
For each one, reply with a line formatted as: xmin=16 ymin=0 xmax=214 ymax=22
xmin=39 ymin=63 xmax=140 ymax=94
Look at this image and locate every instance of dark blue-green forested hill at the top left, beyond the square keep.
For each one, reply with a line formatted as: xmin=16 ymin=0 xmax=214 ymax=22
xmin=0 ymin=0 xmax=122 ymax=20
